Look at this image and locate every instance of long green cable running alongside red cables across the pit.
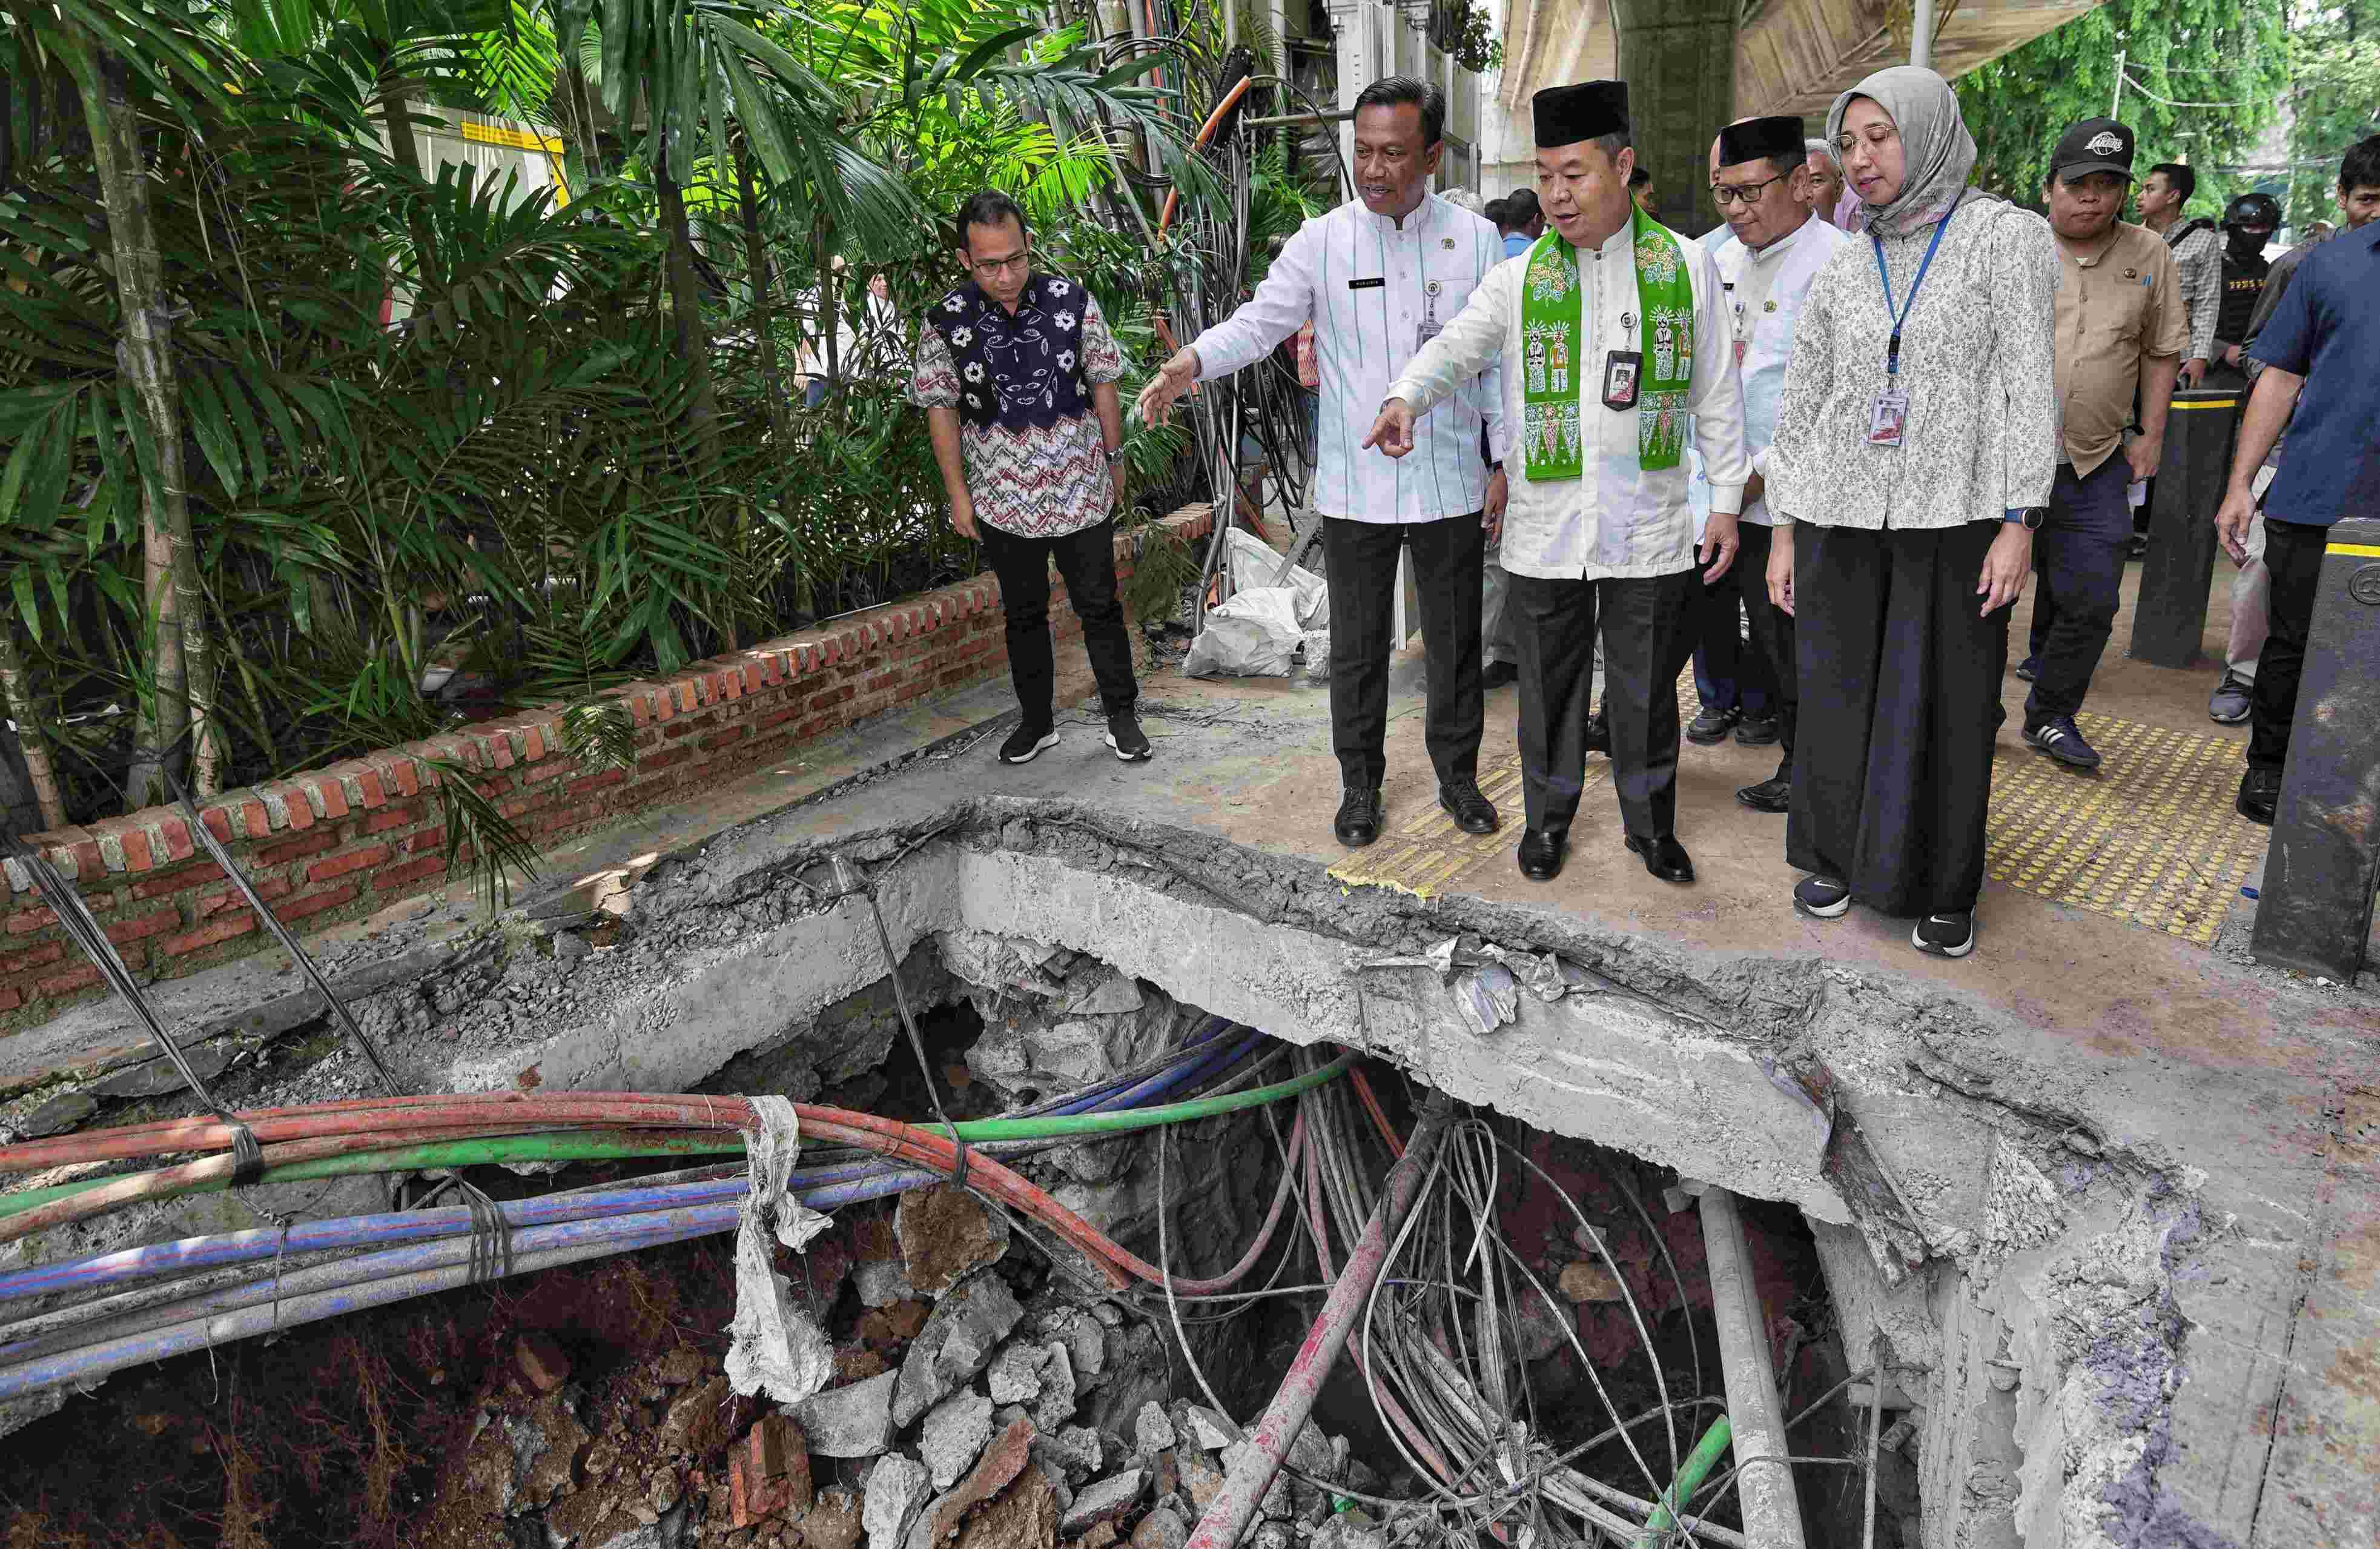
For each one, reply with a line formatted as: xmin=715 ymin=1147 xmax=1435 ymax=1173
xmin=0 ymin=1054 xmax=1354 ymax=1218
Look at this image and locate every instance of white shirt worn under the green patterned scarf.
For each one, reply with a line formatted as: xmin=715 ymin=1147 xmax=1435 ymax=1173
xmin=1390 ymin=226 xmax=1751 ymax=580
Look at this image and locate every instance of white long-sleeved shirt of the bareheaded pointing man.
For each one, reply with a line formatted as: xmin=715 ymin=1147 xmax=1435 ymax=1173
xmin=1190 ymin=195 xmax=1504 ymax=521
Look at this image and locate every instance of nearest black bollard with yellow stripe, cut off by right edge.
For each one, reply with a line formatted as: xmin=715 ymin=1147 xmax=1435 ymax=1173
xmin=2249 ymin=519 xmax=2380 ymax=985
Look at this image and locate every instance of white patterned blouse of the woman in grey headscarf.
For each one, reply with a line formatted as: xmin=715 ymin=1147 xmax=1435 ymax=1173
xmin=1768 ymin=190 xmax=2061 ymax=531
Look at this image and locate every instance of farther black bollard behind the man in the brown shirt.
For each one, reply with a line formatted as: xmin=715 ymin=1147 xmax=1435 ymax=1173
xmin=2125 ymin=380 xmax=2247 ymax=666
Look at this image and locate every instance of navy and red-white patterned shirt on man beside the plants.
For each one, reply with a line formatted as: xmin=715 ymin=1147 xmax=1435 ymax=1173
xmin=909 ymin=274 xmax=1123 ymax=538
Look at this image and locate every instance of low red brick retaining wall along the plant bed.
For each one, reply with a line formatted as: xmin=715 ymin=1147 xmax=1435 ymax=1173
xmin=0 ymin=507 xmax=1209 ymax=1033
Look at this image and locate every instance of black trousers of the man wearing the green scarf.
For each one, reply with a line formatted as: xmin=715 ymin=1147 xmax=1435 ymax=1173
xmin=1509 ymin=571 xmax=1702 ymax=840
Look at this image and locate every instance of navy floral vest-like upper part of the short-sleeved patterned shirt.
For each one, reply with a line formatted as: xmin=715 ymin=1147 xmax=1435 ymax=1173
xmin=926 ymin=274 xmax=1090 ymax=431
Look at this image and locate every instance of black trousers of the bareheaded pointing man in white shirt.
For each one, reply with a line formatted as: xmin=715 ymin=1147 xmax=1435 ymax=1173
xmin=1323 ymin=511 xmax=1487 ymax=788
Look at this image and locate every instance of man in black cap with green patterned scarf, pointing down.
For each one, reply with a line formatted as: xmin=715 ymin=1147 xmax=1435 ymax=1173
xmin=1364 ymin=81 xmax=1751 ymax=883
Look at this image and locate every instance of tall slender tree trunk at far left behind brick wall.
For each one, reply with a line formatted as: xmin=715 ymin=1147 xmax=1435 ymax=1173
xmin=74 ymin=38 xmax=214 ymax=809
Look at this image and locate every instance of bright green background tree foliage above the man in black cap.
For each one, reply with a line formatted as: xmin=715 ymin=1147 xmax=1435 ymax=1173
xmin=1956 ymin=0 xmax=2290 ymax=214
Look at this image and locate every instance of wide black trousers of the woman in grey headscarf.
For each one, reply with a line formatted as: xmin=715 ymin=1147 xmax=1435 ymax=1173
xmin=1785 ymin=521 xmax=2008 ymax=914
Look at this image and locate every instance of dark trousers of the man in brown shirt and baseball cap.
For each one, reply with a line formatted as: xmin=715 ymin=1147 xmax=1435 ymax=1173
xmin=2025 ymin=452 xmax=2132 ymax=726
